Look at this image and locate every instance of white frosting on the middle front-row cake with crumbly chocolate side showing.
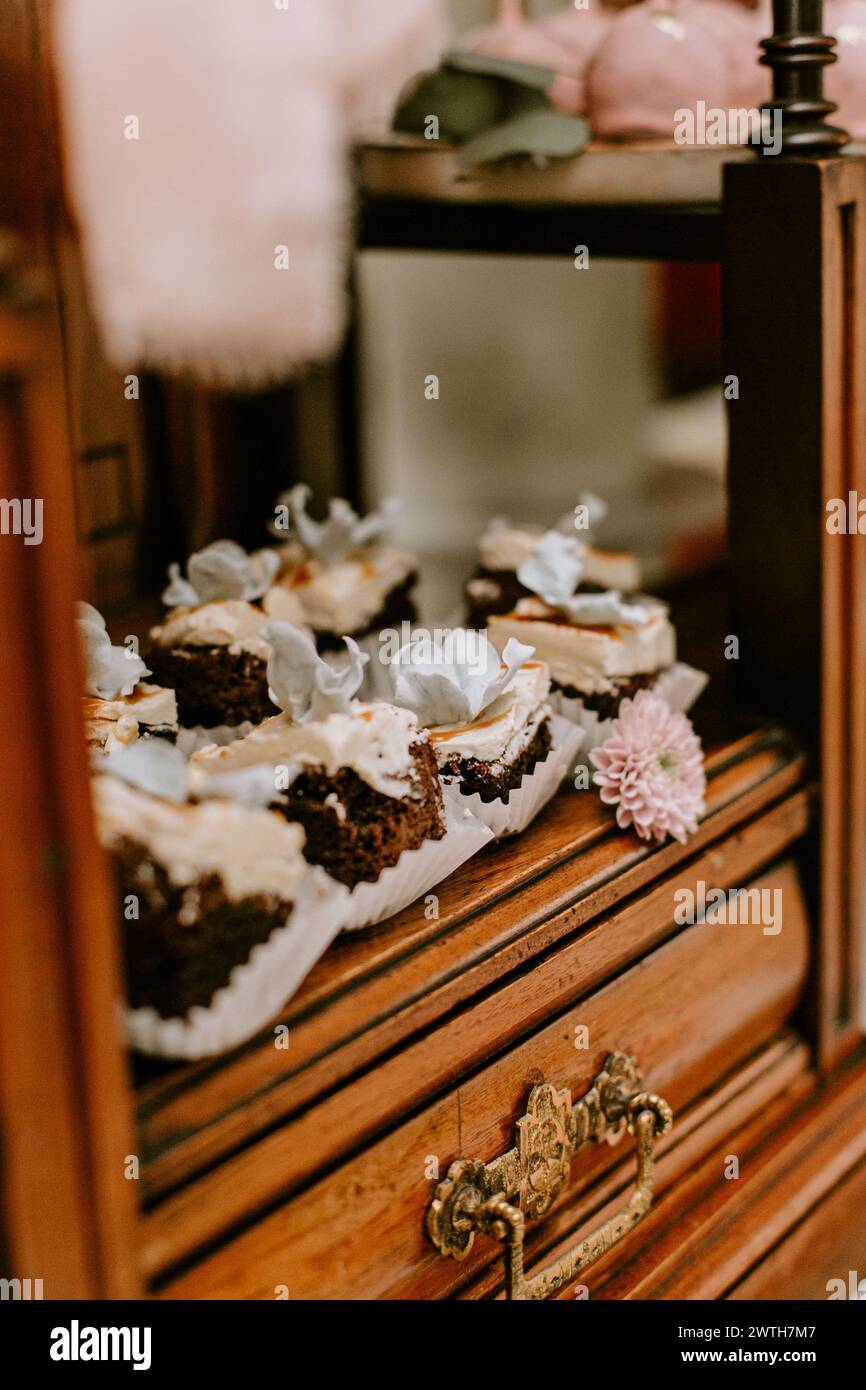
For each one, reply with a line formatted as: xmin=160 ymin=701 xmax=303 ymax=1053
xmin=190 ymin=701 xmax=425 ymax=796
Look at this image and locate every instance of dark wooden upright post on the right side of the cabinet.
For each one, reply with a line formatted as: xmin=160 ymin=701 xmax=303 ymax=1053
xmin=723 ymin=157 xmax=866 ymax=1069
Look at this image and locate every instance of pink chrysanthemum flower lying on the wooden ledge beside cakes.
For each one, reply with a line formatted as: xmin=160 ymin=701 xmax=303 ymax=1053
xmin=589 ymin=691 xmax=706 ymax=845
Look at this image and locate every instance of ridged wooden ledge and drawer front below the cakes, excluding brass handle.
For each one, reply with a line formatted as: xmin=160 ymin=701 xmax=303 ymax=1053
xmin=138 ymin=730 xmax=834 ymax=1298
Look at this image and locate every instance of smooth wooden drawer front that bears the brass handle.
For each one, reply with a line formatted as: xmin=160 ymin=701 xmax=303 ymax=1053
xmin=147 ymin=847 xmax=808 ymax=1298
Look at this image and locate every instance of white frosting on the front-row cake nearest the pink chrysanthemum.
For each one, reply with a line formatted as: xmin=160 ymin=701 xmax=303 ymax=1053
xmin=430 ymin=662 xmax=550 ymax=766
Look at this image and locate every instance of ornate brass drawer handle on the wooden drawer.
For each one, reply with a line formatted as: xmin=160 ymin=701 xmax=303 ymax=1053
xmin=427 ymin=1052 xmax=673 ymax=1300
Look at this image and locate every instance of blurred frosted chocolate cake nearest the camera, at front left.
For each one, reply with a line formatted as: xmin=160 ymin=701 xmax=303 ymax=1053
xmin=93 ymin=759 xmax=307 ymax=1019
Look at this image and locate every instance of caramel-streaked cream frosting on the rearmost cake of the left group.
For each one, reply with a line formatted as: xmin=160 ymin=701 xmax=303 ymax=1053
xmin=272 ymin=545 xmax=417 ymax=637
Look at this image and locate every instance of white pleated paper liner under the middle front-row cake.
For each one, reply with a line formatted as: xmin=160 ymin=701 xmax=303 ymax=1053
xmin=342 ymin=787 xmax=493 ymax=931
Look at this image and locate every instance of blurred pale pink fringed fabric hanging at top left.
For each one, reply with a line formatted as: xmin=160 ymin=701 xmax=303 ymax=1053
xmin=56 ymin=0 xmax=442 ymax=386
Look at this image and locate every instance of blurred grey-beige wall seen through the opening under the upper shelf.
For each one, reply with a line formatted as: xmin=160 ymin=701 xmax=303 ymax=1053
xmin=360 ymin=0 xmax=659 ymax=609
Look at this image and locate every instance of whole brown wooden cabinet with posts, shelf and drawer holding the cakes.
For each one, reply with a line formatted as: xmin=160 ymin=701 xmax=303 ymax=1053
xmin=0 ymin=0 xmax=866 ymax=1300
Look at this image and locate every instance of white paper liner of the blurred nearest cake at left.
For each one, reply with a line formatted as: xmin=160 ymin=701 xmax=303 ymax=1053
xmin=124 ymin=867 xmax=348 ymax=1062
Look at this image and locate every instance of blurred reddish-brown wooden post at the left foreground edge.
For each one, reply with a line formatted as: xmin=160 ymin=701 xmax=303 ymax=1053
xmin=0 ymin=301 xmax=139 ymax=1298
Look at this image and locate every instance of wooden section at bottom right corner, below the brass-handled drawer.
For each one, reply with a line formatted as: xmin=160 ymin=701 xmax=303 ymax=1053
xmin=547 ymin=1036 xmax=866 ymax=1301
